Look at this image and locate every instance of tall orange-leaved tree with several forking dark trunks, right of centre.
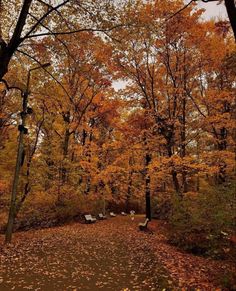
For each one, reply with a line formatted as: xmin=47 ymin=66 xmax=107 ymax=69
xmin=111 ymin=1 xmax=236 ymax=205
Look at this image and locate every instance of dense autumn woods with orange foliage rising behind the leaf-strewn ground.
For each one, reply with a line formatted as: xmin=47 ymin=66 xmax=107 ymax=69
xmin=0 ymin=0 xmax=236 ymax=290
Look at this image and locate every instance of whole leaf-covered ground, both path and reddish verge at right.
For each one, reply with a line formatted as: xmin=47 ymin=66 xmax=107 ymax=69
xmin=0 ymin=216 xmax=236 ymax=291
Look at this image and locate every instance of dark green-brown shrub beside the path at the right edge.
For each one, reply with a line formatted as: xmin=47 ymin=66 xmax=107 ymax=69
xmin=169 ymin=183 xmax=236 ymax=258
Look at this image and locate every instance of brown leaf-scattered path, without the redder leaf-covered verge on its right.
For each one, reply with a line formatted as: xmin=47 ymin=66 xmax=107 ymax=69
xmin=0 ymin=217 xmax=171 ymax=291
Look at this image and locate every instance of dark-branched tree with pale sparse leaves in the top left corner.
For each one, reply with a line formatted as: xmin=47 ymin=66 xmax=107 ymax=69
xmin=0 ymin=0 xmax=123 ymax=80
